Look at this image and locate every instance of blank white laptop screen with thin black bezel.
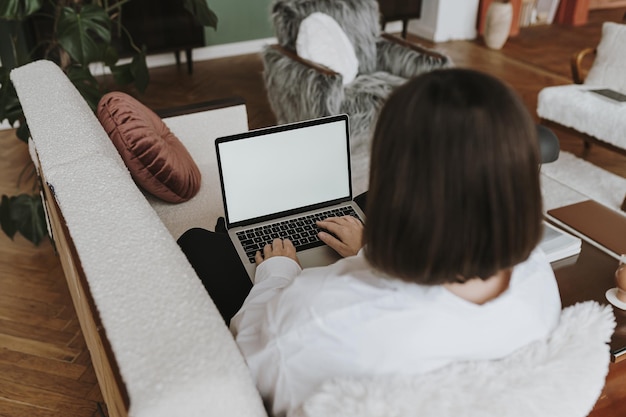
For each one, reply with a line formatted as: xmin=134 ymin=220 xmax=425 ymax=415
xmin=215 ymin=115 xmax=351 ymax=225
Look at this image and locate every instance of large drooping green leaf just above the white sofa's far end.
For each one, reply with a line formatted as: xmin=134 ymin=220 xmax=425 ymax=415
xmin=57 ymin=4 xmax=111 ymax=66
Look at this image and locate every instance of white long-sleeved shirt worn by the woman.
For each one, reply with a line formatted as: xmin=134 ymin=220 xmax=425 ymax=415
xmin=231 ymin=250 xmax=561 ymax=416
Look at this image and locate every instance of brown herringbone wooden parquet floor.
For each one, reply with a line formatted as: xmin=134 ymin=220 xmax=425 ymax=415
xmin=0 ymin=8 xmax=626 ymax=417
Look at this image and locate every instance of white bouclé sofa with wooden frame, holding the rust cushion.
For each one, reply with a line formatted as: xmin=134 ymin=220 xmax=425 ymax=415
xmin=11 ymin=61 xmax=266 ymax=417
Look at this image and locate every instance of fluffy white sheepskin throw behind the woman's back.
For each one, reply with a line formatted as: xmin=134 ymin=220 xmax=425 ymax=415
xmin=291 ymin=301 xmax=615 ymax=417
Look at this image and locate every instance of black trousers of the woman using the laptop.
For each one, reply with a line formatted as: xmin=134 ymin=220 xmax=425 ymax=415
xmin=178 ymin=193 xmax=366 ymax=324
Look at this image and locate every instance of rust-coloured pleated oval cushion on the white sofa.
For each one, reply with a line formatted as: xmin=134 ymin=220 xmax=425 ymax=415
xmin=97 ymin=92 xmax=201 ymax=203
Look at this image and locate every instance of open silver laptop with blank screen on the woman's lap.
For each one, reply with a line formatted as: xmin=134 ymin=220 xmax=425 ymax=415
xmin=215 ymin=114 xmax=365 ymax=279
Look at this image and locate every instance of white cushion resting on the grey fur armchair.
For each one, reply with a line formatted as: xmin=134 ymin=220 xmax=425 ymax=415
xmin=296 ymin=12 xmax=359 ymax=85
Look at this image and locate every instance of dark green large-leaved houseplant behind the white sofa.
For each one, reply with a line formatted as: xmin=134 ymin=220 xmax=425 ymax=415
xmin=0 ymin=0 xmax=217 ymax=245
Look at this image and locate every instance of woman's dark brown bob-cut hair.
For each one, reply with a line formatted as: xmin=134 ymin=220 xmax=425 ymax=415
xmin=365 ymin=69 xmax=542 ymax=285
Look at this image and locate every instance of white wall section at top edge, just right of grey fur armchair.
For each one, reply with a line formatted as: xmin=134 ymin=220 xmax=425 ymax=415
xmin=408 ymin=0 xmax=479 ymax=42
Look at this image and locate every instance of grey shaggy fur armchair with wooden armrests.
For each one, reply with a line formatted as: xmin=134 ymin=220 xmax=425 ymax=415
xmin=262 ymin=0 xmax=451 ymax=193
